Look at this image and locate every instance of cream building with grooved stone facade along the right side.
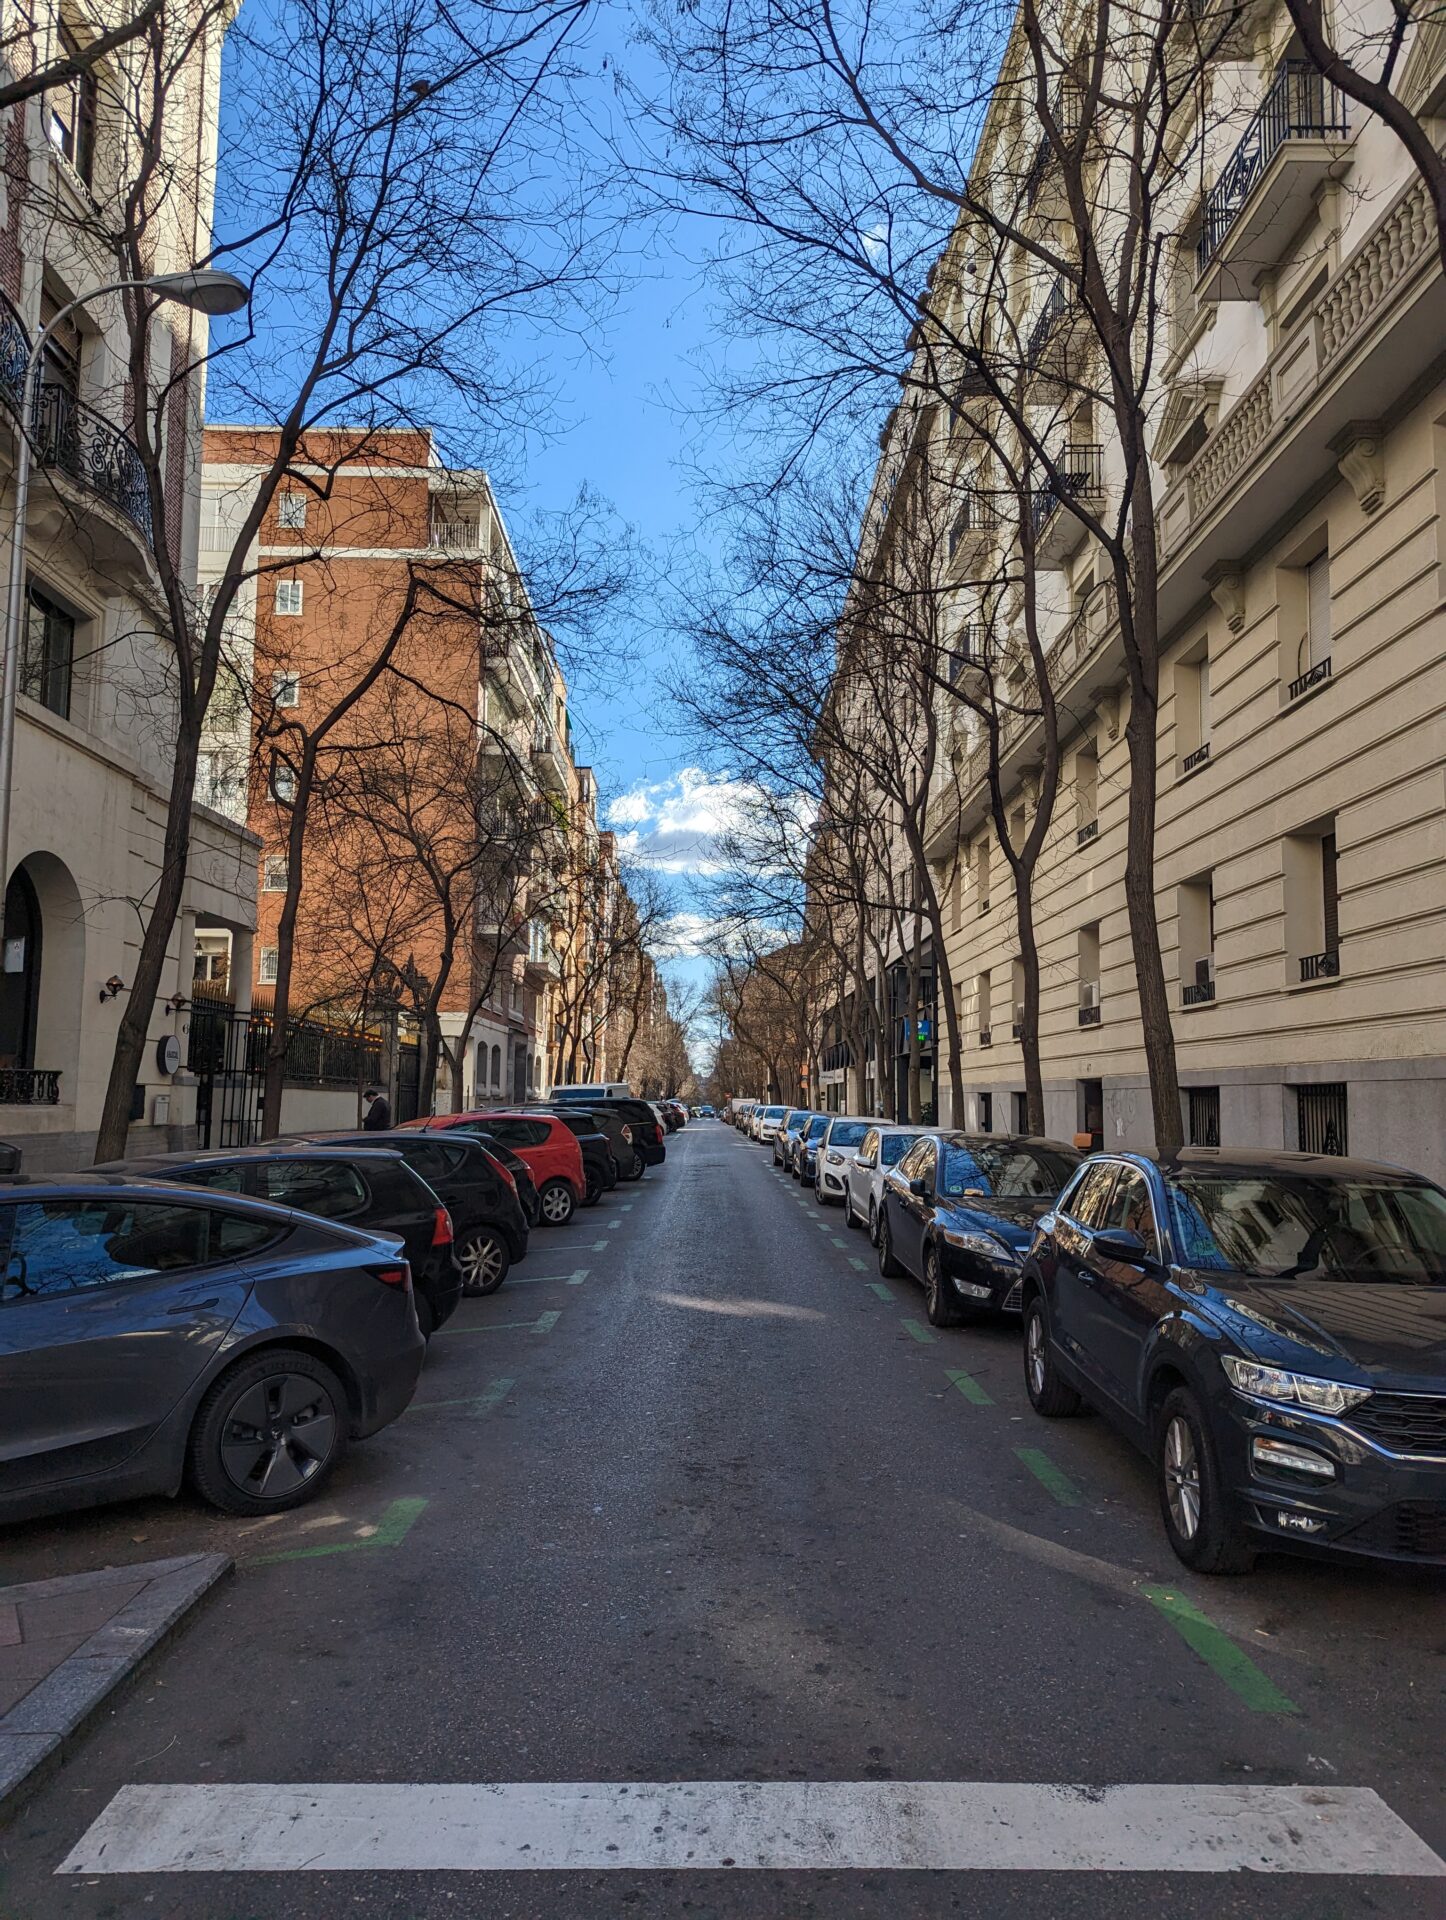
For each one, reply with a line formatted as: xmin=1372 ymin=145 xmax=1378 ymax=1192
xmin=829 ymin=4 xmax=1446 ymax=1177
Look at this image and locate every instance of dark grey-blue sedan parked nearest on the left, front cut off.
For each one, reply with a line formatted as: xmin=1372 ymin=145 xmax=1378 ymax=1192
xmin=0 ymin=1175 xmax=424 ymax=1521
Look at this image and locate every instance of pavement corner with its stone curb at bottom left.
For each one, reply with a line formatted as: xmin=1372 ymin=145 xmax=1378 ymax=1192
xmin=0 ymin=1553 xmax=230 ymax=1816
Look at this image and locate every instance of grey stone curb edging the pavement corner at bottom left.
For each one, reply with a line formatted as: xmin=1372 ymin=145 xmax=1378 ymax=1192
xmin=0 ymin=1553 xmax=234 ymax=1822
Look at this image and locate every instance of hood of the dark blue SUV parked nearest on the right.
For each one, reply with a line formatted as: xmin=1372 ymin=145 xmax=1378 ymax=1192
xmin=1194 ymin=1273 xmax=1446 ymax=1392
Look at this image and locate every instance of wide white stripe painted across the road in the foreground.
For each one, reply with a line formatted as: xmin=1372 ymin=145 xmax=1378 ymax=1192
xmin=58 ymin=1780 xmax=1446 ymax=1878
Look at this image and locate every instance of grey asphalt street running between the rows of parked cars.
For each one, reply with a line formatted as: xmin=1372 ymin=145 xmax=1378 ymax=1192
xmin=0 ymin=1121 xmax=1446 ymax=1920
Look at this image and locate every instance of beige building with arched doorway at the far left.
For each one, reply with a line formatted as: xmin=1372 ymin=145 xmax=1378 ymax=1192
xmin=0 ymin=6 xmax=255 ymax=1173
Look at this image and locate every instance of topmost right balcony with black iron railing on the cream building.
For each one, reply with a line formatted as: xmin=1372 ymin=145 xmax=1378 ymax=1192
xmin=1196 ymin=60 xmax=1350 ymax=300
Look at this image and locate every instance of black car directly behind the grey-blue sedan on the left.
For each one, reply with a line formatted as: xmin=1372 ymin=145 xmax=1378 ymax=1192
xmin=98 ymin=1135 xmax=463 ymax=1338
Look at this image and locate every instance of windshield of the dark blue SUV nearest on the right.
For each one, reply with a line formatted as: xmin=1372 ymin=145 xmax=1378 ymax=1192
xmin=1169 ymin=1173 xmax=1446 ymax=1286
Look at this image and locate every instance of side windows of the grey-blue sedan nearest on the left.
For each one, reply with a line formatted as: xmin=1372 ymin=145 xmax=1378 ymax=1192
xmin=0 ymin=1198 xmax=242 ymax=1304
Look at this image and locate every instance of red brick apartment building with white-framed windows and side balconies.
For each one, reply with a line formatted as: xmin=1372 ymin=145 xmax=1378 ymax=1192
xmin=198 ymin=426 xmax=578 ymax=1106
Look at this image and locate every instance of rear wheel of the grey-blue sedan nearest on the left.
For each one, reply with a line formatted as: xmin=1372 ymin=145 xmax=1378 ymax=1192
xmin=188 ymin=1346 xmax=349 ymax=1513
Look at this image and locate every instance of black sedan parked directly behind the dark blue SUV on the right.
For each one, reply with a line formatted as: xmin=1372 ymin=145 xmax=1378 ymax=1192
xmin=878 ymin=1133 xmax=1081 ymax=1327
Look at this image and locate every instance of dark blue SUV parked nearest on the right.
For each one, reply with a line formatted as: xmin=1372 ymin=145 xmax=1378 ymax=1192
xmin=1024 ymin=1148 xmax=1446 ymax=1572
